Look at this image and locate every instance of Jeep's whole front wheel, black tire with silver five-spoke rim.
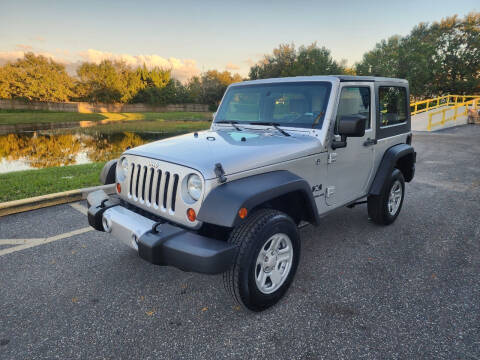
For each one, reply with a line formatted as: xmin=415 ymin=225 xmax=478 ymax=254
xmin=224 ymin=209 xmax=300 ymax=311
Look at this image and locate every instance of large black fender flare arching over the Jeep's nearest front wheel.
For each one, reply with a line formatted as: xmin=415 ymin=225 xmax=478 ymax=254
xmin=197 ymin=170 xmax=319 ymax=228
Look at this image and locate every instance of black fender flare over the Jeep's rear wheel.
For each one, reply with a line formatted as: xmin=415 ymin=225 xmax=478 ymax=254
xmin=368 ymin=144 xmax=417 ymax=195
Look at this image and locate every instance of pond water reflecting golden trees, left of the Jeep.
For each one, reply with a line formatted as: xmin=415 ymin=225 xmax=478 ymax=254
xmin=0 ymin=122 xmax=209 ymax=173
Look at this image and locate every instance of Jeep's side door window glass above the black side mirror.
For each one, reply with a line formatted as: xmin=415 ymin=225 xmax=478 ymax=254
xmin=335 ymin=86 xmax=370 ymax=134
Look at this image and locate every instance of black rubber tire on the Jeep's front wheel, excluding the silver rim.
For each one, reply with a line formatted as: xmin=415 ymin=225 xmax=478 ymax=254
xmin=223 ymin=209 xmax=300 ymax=311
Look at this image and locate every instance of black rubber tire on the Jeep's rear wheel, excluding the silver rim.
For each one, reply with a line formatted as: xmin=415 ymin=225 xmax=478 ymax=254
xmin=367 ymin=169 xmax=405 ymax=225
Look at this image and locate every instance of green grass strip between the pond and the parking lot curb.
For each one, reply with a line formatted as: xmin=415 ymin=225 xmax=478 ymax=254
xmin=0 ymin=163 xmax=104 ymax=202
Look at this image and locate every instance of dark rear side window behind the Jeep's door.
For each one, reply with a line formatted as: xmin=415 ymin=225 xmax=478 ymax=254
xmin=378 ymin=86 xmax=407 ymax=127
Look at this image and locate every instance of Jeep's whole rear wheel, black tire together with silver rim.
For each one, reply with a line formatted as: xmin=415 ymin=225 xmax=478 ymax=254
xmin=368 ymin=169 xmax=405 ymax=225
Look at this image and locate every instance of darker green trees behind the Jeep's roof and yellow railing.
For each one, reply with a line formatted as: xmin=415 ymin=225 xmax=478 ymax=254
xmin=249 ymin=12 xmax=480 ymax=99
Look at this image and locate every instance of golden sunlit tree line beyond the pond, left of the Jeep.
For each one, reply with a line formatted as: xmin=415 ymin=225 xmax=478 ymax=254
xmin=0 ymin=53 xmax=242 ymax=107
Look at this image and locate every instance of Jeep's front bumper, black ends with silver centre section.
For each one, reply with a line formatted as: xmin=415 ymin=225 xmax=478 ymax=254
xmin=87 ymin=190 xmax=237 ymax=274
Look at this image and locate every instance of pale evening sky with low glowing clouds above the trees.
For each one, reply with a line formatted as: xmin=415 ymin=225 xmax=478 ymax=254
xmin=0 ymin=0 xmax=480 ymax=80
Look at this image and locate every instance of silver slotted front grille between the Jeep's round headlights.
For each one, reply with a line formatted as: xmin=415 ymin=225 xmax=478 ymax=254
xmin=128 ymin=162 xmax=180 ymax=214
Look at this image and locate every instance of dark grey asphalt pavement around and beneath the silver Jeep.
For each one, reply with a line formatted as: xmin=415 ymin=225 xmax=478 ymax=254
xmin=0 ymin=126 xmax=480 ymax=359
